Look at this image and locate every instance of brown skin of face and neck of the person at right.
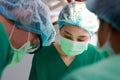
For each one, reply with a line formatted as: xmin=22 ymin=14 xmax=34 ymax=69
xmin=98 ymin=19 xmax=120 ymax=54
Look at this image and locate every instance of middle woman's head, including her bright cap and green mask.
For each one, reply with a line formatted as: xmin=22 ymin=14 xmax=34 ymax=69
xmin=58 ymin=2 xmax=99 ymax=56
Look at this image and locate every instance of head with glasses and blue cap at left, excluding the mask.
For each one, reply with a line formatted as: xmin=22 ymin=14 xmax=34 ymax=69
xmin=0 ymin=0 xmax=55 ymax=52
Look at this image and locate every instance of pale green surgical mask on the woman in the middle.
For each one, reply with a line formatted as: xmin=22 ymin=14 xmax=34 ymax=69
xmin=59 ymin=36 xmax=88 ymax=56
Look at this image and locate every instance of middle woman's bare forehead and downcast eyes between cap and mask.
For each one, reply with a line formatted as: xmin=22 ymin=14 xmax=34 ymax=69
xmin=60 ymin=25 xmax=90 ymax=42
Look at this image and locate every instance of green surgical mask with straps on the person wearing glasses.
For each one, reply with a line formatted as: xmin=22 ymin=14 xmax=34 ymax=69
xmin=8 ymin=24 xmax=38 ymax=66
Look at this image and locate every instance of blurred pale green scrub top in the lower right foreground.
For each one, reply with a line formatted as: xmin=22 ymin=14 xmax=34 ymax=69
xmin=60 ymin=55 xmax=120 ymax=80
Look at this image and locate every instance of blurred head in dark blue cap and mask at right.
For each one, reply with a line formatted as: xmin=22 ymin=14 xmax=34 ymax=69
xmin=86 ymin=0 xmax=120 ymax=55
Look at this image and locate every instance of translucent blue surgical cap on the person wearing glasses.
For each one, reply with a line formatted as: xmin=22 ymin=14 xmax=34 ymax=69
xmin=0 ymin=0 xmax=56 ymax=46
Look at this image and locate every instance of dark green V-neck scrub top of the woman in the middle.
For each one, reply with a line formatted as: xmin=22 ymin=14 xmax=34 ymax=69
xmin=29 ymin=44 xmax=102 ymax=80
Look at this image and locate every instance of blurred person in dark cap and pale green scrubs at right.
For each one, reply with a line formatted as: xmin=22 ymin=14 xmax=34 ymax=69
xmin=61 ymin=0 xmax=120 ymax=80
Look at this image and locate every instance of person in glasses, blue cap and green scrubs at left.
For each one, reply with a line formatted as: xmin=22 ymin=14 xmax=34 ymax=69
xmin=0 ymin=0 xmax=55 ymax=77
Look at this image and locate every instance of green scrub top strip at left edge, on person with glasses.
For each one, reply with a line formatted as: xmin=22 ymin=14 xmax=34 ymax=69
xmin=0 ymin=22 xmax=13 ymax=79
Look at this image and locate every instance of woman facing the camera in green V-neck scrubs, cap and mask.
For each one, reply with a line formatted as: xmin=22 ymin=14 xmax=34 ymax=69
xmin=29 ymin=2 xmax=102 ymax=80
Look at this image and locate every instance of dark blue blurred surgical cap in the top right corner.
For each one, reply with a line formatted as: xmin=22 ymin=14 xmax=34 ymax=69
xmin=86 ymin=0 xmax=120 ymax=30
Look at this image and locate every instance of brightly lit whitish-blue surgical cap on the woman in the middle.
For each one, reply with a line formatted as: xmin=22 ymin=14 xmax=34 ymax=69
xmin=58 ymin=2 xmax=99 ymax=36
